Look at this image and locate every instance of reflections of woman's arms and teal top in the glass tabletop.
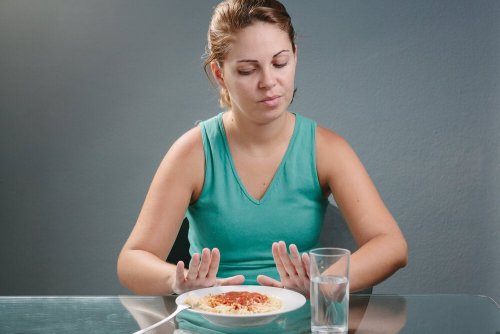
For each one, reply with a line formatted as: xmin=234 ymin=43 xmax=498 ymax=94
xmin=120 ymin=295 xmax=407 ymax=334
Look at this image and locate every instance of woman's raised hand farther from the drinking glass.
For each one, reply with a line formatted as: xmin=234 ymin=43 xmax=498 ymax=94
xmin=172 ymin=248 xmax=245 ymax=294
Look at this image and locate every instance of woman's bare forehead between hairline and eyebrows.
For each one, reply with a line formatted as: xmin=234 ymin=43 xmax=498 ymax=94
xmin=226 ymin=22 xmax=292 ymax=61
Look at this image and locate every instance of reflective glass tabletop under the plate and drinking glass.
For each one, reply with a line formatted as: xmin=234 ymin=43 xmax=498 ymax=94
xmin=0 ymin=295 xmax=500 ymax=334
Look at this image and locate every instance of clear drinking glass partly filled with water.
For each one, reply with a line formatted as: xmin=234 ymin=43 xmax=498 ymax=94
xmin=309 ymin=248 xmax=351 ymax=333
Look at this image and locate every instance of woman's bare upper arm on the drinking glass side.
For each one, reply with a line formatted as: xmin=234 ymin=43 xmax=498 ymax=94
xmin=316 ymin=127 xmax=400 ymax=245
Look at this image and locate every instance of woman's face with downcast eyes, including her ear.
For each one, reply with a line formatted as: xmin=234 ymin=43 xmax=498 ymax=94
xmin=213 ymin=22 xmax=297 ymax=122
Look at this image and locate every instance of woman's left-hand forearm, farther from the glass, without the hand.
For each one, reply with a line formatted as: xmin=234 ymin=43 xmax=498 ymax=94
xmin=118 ymin=250 xmax=176 ymax=295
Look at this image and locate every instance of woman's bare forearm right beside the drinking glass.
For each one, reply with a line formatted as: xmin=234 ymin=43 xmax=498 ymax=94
xmin=349 ymin=235 xmax=408 ymax=292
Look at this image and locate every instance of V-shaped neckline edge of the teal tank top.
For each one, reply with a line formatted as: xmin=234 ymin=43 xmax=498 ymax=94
xmin=219 ymin=112 xmax=299 ymax=205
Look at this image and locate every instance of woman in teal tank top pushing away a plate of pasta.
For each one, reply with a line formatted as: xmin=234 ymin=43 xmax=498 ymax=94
xmin=118 ymin=0 xmax=407 ymax=295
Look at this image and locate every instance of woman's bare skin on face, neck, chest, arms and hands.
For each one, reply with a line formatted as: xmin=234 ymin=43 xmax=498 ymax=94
xmin=118 ymin=22 xmax=407 ymax=296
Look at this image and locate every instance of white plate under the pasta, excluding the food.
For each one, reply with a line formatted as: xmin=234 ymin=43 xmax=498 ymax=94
xmin=175 ymin=285 xmax=306 ymax=327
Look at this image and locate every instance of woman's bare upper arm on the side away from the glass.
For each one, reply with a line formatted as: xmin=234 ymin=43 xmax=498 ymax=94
xmin=124 ymin=127 xmax=205 ymax=258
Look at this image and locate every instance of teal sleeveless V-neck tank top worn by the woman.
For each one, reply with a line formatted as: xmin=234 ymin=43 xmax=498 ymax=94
xmin=186 ymin=113 xmax=328 ymax=284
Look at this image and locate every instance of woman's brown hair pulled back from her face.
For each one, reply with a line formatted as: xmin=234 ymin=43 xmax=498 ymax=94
xmin=203 ymin=0 xmax=295 ymax=109
